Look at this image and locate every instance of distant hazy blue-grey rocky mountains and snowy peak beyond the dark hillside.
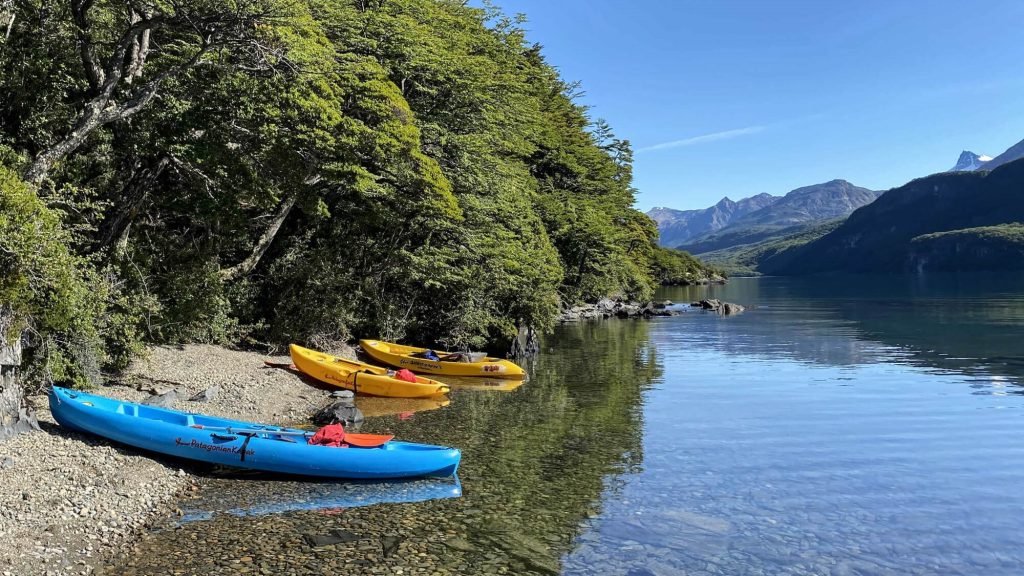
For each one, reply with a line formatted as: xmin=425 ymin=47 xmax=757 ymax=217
xmin=647 ymin=134 xmax=1024 ymax=268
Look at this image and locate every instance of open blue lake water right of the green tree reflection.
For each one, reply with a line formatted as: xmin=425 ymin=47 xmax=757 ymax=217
xmin=563 ymin=278 xmax=1024 ymax=575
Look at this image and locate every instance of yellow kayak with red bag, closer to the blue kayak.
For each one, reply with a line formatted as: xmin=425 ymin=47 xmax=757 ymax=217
xmin=291 ymin=344 xmax=451 ymax=398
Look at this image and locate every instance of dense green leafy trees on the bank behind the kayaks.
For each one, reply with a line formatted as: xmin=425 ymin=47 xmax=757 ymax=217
xmin=0 ymin=0 xmax=706 ymax=389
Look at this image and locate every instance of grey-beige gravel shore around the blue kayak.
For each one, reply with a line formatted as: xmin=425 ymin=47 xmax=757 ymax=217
xmin=0 ymin=345 xmax=351 ymax=576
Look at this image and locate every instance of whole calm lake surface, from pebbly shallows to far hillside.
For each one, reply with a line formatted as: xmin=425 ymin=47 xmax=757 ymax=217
xmin=109 ymin=276 xmax=1024 ymax=576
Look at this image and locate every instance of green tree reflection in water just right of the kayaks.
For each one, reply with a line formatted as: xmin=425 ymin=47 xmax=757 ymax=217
xmin=368 ymin=321 xmax=662 ymax=572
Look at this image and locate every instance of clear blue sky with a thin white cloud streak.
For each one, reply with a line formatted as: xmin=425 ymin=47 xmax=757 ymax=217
xmin=483 ymin=0 xmax=1024 ymax=210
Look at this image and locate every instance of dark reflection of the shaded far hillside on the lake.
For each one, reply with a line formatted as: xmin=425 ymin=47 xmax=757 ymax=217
xmin=665 ymin=274 xmax=1024 ymax=382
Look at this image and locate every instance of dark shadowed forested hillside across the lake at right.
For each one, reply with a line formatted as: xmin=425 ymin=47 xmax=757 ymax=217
xmin=757 ymin=156 xmax=1024 ymax=275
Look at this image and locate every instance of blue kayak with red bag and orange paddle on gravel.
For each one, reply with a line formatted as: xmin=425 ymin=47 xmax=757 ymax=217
xmin=50 ymin=386 xmax=462 ymax=479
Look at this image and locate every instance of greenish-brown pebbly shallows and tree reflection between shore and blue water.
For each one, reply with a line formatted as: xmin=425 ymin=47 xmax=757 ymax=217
xmin=110 ymin=321 xmax=663 ymax=575
